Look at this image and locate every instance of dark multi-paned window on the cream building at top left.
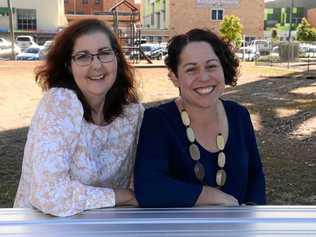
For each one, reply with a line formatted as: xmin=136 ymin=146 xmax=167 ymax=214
xmin=16 ymin=9 xmax=37 ymax=31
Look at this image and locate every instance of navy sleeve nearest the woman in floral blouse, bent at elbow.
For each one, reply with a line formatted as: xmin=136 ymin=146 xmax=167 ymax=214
xmin=134 ymin=109 xmax=202 ymax=207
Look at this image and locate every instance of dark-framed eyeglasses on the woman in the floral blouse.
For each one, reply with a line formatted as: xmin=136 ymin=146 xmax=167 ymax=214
xmin=71 ymin=50 xmax=115 ymax=67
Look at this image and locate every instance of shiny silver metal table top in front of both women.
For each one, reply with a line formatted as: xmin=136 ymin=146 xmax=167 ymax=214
xmin=0 ymin=206 xmax=316 ymax=237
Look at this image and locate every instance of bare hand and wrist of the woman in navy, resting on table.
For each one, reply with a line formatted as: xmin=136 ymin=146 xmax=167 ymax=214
xmin=195 ymin=186 xmax=239 ymax=206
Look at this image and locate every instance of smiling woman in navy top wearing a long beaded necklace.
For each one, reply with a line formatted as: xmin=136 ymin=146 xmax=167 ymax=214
xmin=134 ymin=29 xmax=266 ymax=207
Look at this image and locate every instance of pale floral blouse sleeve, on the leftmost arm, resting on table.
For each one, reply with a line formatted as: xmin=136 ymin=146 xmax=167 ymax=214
xmin=15 ymin=89 xmax=115 ymax=216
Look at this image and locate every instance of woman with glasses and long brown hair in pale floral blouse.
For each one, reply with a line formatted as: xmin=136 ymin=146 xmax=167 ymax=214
xmin=14 ymin=19 xmax=143 ymax=216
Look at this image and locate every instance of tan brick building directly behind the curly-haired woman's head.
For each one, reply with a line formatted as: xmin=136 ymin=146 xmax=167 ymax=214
xmin=141 ymin=0 xmax=264 ymax=42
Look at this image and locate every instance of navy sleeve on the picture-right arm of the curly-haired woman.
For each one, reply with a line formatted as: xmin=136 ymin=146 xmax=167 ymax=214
xmin=245 ymin=108 xmax=266 ymax=205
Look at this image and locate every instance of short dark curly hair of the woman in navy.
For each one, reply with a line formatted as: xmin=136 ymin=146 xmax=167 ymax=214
xmin=165 ymin=29 xmax=239 ymax=86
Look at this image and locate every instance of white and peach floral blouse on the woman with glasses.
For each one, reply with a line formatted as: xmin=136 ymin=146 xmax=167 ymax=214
xmin=14 ymin=88 xmax=144 ymax=216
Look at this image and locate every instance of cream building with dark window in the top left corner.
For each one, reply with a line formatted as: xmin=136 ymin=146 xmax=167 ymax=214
xmin=0 ymin=0 xmax=67 ymax=33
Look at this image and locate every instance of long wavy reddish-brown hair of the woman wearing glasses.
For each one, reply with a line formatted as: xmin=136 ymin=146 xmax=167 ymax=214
xmin=35 ymin=19 xmax=138 ymax=123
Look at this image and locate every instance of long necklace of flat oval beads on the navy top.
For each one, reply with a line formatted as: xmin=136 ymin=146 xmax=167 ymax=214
xmin=179 ymin=99 xmax=227 ymax=188
